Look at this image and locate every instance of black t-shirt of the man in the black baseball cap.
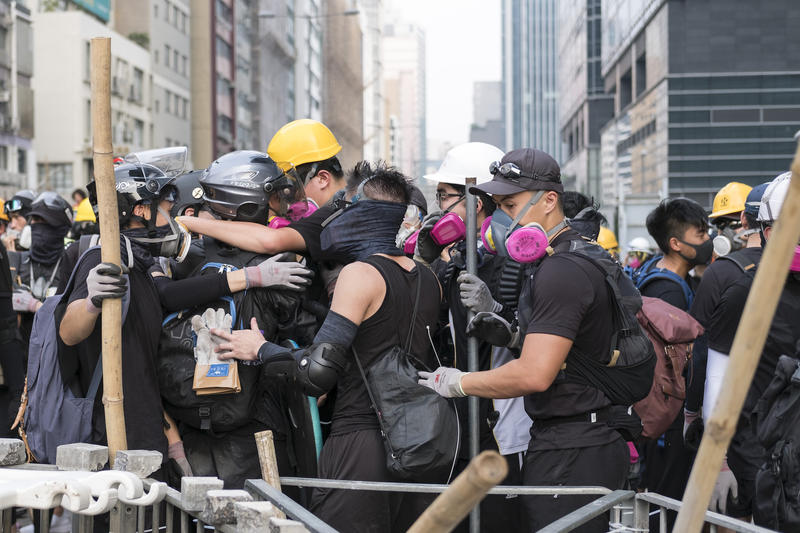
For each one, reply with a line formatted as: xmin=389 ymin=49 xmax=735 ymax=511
xmin=520 ymin=230 xmax=620 ymax=451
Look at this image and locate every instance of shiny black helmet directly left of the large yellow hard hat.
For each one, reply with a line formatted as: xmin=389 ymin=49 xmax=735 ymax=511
xmin=200 ymin=150 xmax=303 ymax=224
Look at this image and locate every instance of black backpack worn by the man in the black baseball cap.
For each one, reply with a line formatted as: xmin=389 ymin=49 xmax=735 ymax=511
xmin=545 ymin=238 xmax=656 ymax=406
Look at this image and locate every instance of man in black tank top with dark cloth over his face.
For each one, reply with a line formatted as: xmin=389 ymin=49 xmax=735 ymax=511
xmin=212 ymin=162 xmax=447 ymax=533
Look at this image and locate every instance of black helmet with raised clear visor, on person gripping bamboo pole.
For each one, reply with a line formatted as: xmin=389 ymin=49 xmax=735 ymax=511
xmin=86 ymin=163 xmax=175 ymax=229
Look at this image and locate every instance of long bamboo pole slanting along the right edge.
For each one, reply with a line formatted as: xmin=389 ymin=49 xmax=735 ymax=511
xmin=674 ymin=143 xmax=800 ymax=533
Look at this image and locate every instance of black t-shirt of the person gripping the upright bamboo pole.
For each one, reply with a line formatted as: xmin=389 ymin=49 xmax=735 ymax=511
xmin=55 ymin=249 xmax=167 ymax=459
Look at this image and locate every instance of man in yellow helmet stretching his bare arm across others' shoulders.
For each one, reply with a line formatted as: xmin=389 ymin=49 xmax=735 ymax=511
xmin=178 ymin=119 xmax=345 ymax=257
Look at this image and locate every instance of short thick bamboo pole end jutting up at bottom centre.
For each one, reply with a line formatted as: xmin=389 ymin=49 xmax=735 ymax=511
xmin=408 ymin=450 xmax=508 ymax=533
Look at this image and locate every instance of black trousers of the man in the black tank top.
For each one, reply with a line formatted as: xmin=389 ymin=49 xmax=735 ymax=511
xmin=310 ymin=429 xmax=436 ymax=533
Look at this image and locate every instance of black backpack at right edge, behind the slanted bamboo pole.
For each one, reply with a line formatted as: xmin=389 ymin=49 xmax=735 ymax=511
xmin=751 ymin=355 xmax=800 ymax=531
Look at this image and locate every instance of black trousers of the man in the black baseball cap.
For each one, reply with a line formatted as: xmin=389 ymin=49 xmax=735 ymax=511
xmin=522 ymin=438 xmax=630 ymax=533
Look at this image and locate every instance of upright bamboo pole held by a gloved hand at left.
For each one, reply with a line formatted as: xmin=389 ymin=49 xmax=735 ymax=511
xmin=91 ymin=37 xmax=128 ymax=466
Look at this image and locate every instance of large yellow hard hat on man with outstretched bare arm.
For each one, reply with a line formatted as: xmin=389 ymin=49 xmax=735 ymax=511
xmin=267 ymin=118 xmax=342 ymax=172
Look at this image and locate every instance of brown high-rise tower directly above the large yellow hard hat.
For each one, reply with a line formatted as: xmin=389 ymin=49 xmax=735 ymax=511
xmin=322 ymin=0 xmax=366 ymax=168
